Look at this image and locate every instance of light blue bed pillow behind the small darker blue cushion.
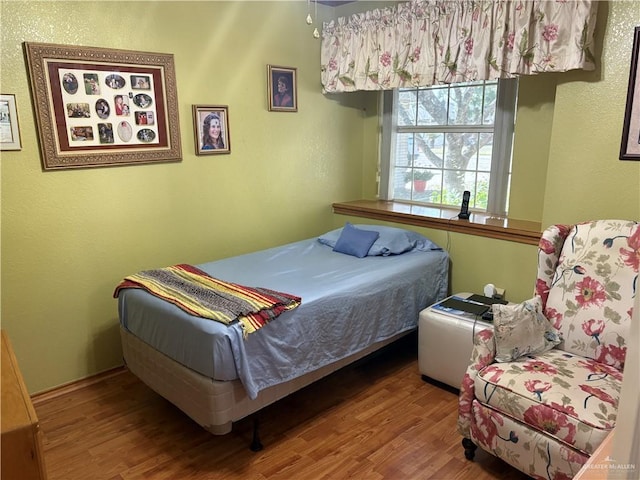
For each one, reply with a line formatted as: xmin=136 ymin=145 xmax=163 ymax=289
xmin=318 ymin=225 xmax=442 ymax=257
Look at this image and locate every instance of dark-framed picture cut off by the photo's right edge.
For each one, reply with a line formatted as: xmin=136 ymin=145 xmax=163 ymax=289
xmin=620 ymin=27 xmax=640 ymax=160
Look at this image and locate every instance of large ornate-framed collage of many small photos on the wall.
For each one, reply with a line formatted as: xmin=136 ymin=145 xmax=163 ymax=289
xmin=24 ymin=42 xmax=182 ymax=170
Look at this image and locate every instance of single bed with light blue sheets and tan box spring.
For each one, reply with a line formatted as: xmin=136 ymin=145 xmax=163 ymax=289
xmin=114 ymin=224 xmax=449 ymax=435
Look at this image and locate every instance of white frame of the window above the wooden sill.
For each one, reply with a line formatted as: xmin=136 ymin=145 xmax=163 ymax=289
xmin=378 ymin=78 xmax=518 ymax=216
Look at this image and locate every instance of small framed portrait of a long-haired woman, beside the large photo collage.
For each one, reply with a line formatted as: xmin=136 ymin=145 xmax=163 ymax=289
xmin=193 ymin=105 xmax=231 ymax=155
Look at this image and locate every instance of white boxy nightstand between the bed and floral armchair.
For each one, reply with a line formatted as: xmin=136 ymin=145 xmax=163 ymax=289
xmin=418 ymin=293 xmax=493 ymax=389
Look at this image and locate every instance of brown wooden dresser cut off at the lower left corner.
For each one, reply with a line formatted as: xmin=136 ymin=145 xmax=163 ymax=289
xmin=0 ymin=330 xmax=47 ymax=480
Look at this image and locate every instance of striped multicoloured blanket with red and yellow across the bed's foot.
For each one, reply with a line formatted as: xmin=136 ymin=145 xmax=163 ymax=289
xmin=113 ymin=264 xmax=302 ymax=337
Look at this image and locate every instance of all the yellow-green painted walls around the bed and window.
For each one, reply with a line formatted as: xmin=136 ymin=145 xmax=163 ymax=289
xmin=0 ymin=0 xmax=640 ymax=393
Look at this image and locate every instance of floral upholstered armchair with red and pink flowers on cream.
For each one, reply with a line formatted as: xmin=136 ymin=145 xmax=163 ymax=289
xmin=458 ymin=220 xmax=640 ymax=480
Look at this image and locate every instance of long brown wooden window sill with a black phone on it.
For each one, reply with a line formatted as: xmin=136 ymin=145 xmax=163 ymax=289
xmin=333 ymin=200 xmax=541 ymax=245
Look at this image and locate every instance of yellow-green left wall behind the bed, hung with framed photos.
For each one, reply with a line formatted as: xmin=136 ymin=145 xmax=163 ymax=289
xmin=0 ymin=1 xmax=363 ymax=393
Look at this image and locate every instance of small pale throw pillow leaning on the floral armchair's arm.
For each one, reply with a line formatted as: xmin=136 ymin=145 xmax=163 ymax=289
xmin=492 ymin=296 xmax=560 ymax=362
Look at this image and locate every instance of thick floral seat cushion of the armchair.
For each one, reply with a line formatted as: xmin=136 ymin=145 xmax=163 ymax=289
xmin=474 ymin=349 xmax=622 ymax=455
